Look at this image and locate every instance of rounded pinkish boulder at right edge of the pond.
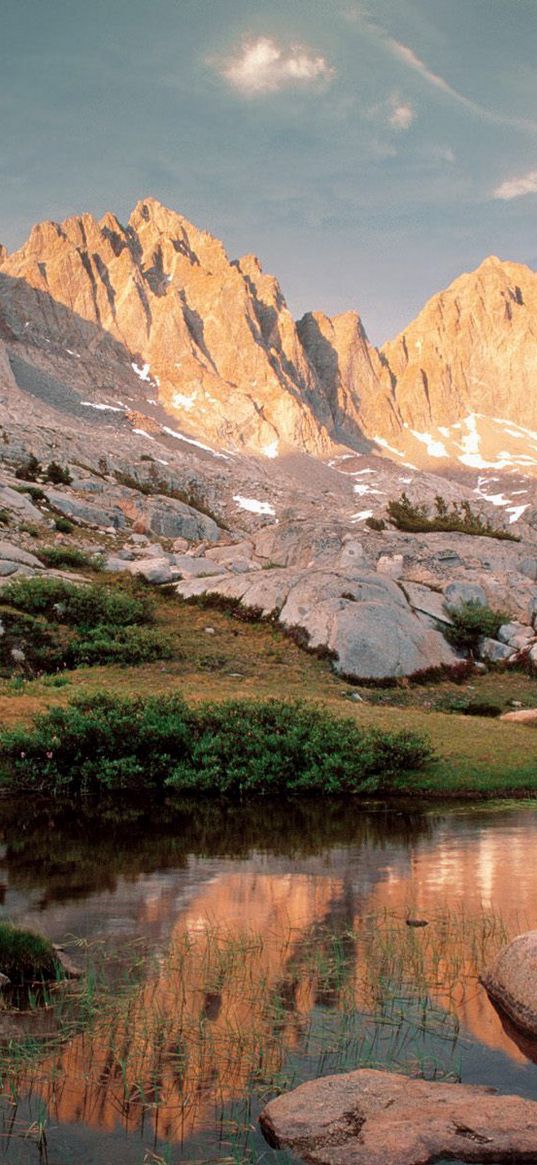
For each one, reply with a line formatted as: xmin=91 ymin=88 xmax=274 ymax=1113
xmin=481 ymin=927 xmax=537 ymax=1039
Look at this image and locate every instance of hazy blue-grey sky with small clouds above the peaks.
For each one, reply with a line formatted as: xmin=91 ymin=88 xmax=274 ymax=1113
xmin=0 ymin=0 xmax=537 ymax=343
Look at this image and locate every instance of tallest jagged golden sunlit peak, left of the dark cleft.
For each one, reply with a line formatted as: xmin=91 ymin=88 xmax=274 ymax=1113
xmin=1 ymin=199 xmax=332 ymax=457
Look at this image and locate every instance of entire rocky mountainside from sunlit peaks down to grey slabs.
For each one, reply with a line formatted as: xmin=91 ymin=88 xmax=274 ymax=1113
xmin=0 ymin=199 xmax=537 ymax=680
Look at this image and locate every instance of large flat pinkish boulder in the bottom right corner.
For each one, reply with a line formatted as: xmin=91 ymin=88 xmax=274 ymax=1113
xmin=260 ymin=1069 xmax=537 ymax=1165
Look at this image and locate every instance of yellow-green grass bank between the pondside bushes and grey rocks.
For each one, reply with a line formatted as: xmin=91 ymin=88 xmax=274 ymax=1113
xmin=0 ymin=594 xmax=537 ymax=796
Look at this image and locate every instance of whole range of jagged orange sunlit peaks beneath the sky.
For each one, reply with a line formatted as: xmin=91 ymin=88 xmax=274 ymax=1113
xmin=0 ymin=199 xmax=537 ymax=473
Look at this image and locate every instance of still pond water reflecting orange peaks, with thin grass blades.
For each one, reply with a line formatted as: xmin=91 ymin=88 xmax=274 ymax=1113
xmin=0 ymin=802 xmax=537 ymax=1165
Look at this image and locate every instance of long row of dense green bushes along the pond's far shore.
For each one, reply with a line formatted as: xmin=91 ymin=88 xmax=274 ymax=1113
xmin=0 ymin=693 xmax=432 ymax=796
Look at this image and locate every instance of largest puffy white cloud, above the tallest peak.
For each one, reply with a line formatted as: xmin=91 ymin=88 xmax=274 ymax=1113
xmin=217 ymin=36 xmax=335 ymax=97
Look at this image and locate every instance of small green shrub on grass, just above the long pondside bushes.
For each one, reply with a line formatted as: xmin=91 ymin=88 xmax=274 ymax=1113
xmin=68 ymin=624 xmax=174 ymax=668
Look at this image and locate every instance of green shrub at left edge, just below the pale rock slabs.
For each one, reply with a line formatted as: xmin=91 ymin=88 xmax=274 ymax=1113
xmin=2 ymin=577 xmax=153 ymax=628
